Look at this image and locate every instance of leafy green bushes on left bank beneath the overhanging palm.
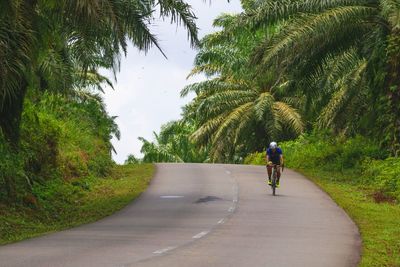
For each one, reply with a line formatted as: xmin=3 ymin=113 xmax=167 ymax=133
xmin=0 ymin=92 xmax=119 ymax=203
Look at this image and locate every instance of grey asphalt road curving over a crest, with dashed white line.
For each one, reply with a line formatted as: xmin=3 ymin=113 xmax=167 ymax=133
xmin=0 ymin=164 xmax=361 ymax=267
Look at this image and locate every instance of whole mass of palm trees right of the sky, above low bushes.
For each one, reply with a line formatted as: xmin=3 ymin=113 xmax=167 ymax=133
xmin=144 ymin=0 xmax=400 ymax=170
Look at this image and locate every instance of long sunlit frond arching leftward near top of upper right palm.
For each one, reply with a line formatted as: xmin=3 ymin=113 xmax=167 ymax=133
xmin=257 ymin=6 xmax=376 ymax=64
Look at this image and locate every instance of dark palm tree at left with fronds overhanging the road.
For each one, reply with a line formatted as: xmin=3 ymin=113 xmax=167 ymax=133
xmin=0 ymin=0 xmax=197 ymax=145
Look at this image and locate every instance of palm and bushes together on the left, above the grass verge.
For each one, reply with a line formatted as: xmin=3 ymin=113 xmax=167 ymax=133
xmin=0 ymin=0 xmax=198 ymax=203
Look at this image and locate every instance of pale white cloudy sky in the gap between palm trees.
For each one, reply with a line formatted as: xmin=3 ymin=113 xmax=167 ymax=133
xmin=104 ymin=0 xmax=241 ymax=163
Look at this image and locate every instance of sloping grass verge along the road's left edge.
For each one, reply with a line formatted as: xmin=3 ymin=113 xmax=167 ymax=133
xmin=0 ymin=164 xmax=155 ymax=244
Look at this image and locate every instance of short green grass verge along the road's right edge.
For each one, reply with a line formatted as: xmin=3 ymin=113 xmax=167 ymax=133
xmin=290 ymin=169 xmax=400 ymax=267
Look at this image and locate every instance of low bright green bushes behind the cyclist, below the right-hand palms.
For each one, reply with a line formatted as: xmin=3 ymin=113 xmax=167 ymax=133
xmin=244 ymin=133 xmax=400 ymax=201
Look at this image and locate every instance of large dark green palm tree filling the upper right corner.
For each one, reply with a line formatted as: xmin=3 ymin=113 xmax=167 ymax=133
xmin=236 ymin=0 xmax=400 ymax=153
